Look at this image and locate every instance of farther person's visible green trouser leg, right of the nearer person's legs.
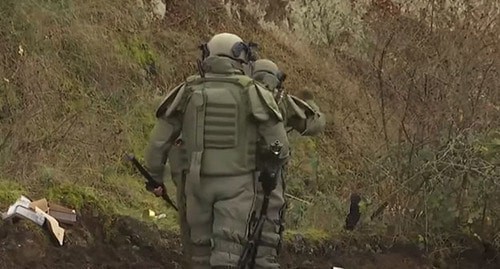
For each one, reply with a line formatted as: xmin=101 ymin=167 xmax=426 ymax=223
xmin=254 ymin=169 xmax=286 ymax=269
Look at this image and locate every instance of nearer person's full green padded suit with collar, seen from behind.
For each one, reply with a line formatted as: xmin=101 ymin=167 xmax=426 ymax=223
xmin=145 ymin=57 xmax=289 ymax=269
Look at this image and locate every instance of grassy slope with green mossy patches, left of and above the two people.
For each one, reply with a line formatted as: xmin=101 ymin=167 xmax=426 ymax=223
xmin=0 ymin=0 xmax=356 ymax=231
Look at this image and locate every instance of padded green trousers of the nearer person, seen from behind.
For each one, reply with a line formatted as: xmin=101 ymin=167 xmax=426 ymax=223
xmin=185 ymin=173 xmax=255 ymax=269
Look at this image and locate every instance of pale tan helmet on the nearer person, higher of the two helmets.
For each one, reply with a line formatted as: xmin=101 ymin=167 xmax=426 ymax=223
xmin=200 ymin=33 xmax=257 ymax=63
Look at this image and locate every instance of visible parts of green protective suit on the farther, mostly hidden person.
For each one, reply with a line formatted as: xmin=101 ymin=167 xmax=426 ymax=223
xmin=250 ymin=73 xmax=326 ymax=268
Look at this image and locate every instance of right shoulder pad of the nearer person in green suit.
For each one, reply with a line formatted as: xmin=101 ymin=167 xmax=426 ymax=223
xmin=248 ymin=84 xmax=283 ymax=121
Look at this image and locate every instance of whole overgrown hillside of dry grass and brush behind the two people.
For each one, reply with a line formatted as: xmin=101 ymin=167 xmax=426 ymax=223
xmin=0 ymin=0 xmax=500 ymax=266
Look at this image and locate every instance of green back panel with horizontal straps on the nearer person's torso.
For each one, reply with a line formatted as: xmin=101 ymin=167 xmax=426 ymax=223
xmin=182 ymin=74 xmax=266 ymax=176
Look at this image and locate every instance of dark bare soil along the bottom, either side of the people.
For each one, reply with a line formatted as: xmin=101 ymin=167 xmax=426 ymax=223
xmin=0 ymin=210 xmax=500 ymax=269
